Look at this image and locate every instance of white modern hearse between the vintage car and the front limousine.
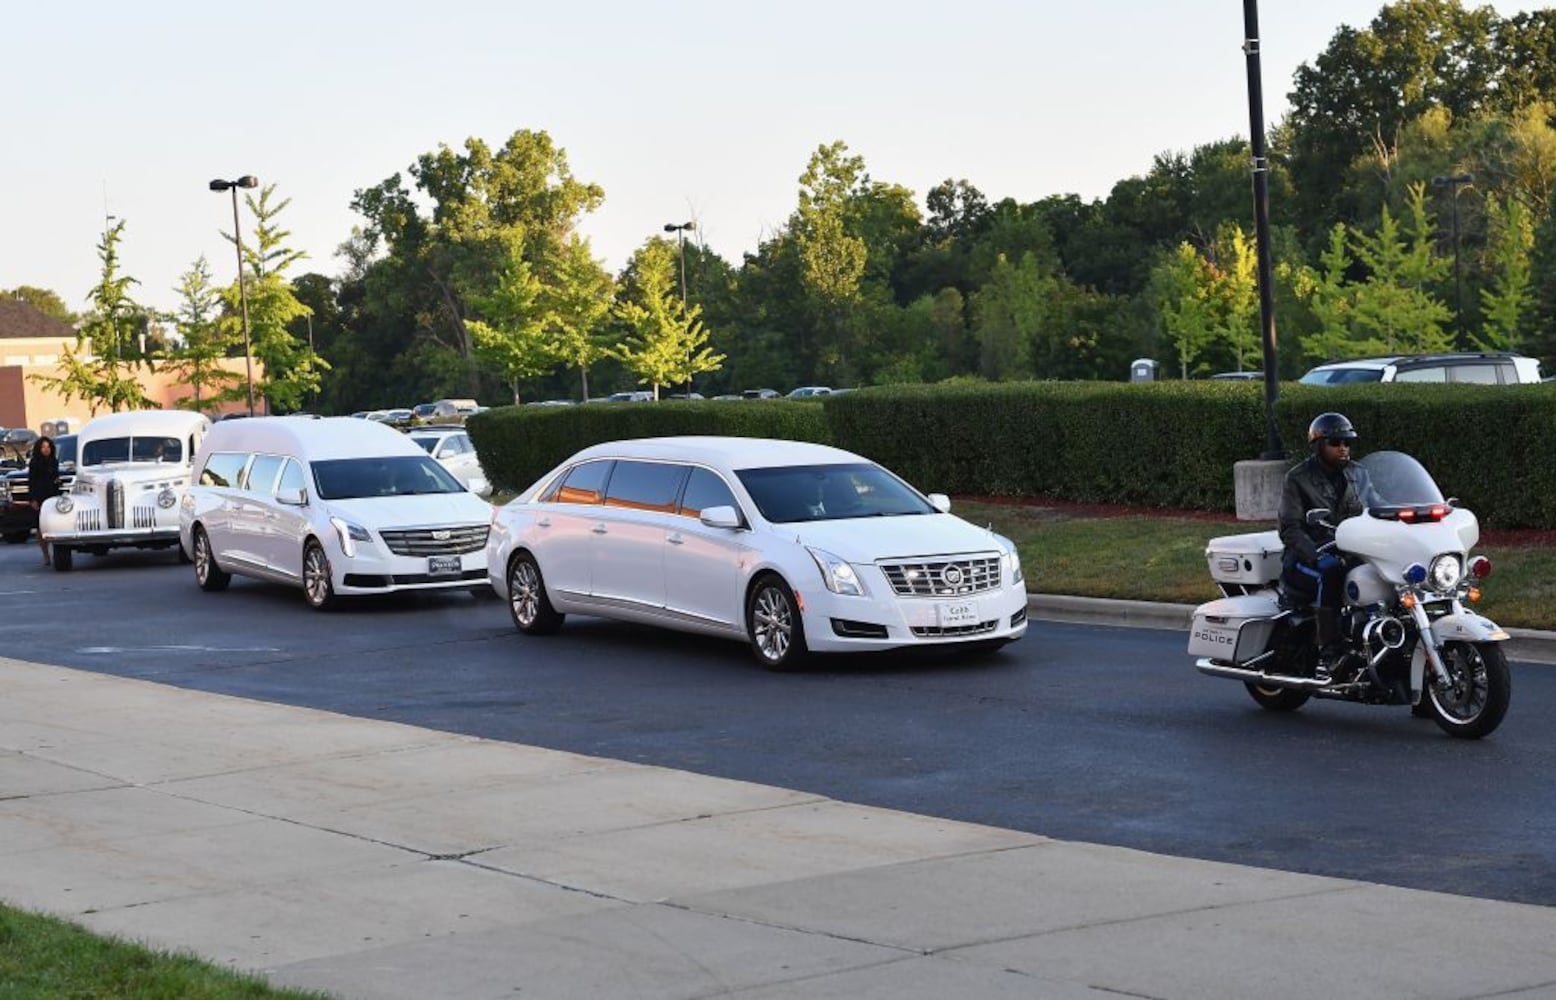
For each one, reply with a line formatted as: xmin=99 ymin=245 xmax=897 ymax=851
xmin=179 ymin=417 xmax=492 ymax=608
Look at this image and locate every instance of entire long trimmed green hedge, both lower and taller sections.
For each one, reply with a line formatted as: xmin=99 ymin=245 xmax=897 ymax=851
xmin=470 ymin=381 xmax=1556 ymax=529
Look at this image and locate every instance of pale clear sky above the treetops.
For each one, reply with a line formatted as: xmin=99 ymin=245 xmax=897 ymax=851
xmin=0 ymin=0 xmax=1534 ymax=317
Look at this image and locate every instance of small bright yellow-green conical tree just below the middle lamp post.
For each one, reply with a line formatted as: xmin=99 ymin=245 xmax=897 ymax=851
xmin=613 ymin=236 xmax=724 ymax=400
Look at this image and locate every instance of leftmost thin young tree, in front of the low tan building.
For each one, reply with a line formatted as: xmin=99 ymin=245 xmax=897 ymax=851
xmin=28 ymin=219 xmax=152 ymax=414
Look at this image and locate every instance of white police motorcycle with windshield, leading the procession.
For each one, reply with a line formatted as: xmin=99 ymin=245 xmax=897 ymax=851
xmin=1189 ymin=451 xmax=1512 ymax=739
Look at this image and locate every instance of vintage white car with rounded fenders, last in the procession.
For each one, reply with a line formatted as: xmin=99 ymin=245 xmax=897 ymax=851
xmin=37 ymin=409 xmax=210 ymax=572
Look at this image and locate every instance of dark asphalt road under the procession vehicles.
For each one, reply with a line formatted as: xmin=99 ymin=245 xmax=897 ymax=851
xmin=0 ymin=546 xmax=1556 ymax=905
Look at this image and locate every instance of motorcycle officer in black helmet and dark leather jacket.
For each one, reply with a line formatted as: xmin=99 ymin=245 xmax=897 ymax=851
xmin=1277 ymin=412 xmax=1376 ymax=684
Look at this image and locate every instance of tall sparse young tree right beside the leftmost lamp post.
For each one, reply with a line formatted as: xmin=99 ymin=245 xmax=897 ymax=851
xmin=223 ymin=184 xmax=330 ymax=412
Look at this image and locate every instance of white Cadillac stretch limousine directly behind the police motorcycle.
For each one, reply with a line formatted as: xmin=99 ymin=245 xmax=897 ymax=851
xmin=487 ymin=437 xmax=1027 ymax=670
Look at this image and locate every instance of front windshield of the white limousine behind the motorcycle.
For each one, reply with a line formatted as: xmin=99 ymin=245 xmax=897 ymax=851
xmin=734 ymin=462 xmax=938 ymax=524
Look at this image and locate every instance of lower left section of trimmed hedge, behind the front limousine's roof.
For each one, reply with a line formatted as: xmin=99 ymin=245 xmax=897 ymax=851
xmin=465 ymin=400 xmax=829 ymax=490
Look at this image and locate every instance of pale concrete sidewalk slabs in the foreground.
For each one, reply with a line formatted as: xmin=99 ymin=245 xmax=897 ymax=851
xmin=0 ymin=659 xmax=1556 ymax=1000
